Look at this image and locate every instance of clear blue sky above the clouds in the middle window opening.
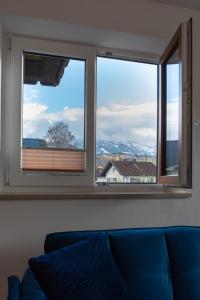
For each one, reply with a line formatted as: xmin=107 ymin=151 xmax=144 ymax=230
xmin=97 ymin=57 xmax=157 ymax=105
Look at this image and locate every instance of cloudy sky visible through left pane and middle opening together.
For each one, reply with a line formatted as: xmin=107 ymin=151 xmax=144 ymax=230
xmin=23 ymin=57 xmax=161 ymax=145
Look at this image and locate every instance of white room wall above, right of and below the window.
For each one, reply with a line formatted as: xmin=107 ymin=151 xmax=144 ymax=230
xmin=0 ymin=0 xmax=200 ymax=299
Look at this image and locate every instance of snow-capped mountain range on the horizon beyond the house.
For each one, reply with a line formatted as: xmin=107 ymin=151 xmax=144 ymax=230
xmin=96 ymin=141 xmax=156 ymax=156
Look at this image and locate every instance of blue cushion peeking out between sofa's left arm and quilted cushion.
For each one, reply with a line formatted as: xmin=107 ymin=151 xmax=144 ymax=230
xmin=20 ymin=269 xmax=47 ymax=300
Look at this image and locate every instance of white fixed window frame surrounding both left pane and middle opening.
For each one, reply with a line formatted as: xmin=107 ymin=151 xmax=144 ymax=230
xmin=2 ymin=21 xmax=191 ymax=194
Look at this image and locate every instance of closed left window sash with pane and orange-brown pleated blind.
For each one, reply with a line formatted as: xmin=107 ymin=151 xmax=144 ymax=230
xmin=5 ymin=37 xmax=96 ymax=186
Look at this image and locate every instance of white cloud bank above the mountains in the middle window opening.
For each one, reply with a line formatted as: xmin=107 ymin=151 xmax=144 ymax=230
xmin=97 ymin=102 xmax=157 ymax=145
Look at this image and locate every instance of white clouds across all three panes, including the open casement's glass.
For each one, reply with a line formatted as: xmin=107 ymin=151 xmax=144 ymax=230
xmin=23 ymin=89 xmax=178 ymax=145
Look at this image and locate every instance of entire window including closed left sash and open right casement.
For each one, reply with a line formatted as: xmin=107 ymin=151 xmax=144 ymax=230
xmin=5 ymin=22 xmax=191 ymax=187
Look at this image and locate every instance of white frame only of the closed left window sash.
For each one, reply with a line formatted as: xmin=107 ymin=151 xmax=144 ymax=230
xmin=4 ymin=36 xmax=96 ymax=186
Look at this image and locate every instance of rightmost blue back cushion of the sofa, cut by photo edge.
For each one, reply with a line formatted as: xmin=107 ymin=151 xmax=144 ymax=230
xmin=165 ymin=227 xmax=200 ymax=300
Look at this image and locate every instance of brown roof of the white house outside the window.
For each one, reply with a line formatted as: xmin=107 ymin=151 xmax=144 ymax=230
xmin=101 ymin=161 xmax=156 ymax=177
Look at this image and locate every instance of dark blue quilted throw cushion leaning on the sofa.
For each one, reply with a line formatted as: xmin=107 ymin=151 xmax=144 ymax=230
xmin=29 ymin=233 xmax=128 ymax=300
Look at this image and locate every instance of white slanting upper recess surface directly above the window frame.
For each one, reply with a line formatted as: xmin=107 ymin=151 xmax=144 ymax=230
xmin=1 ymin=15 xmax=168 ymax=57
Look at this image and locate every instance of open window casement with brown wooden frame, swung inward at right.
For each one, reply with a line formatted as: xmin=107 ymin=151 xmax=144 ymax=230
xmin=158 ymin=20 xmax=192 ymax=187
